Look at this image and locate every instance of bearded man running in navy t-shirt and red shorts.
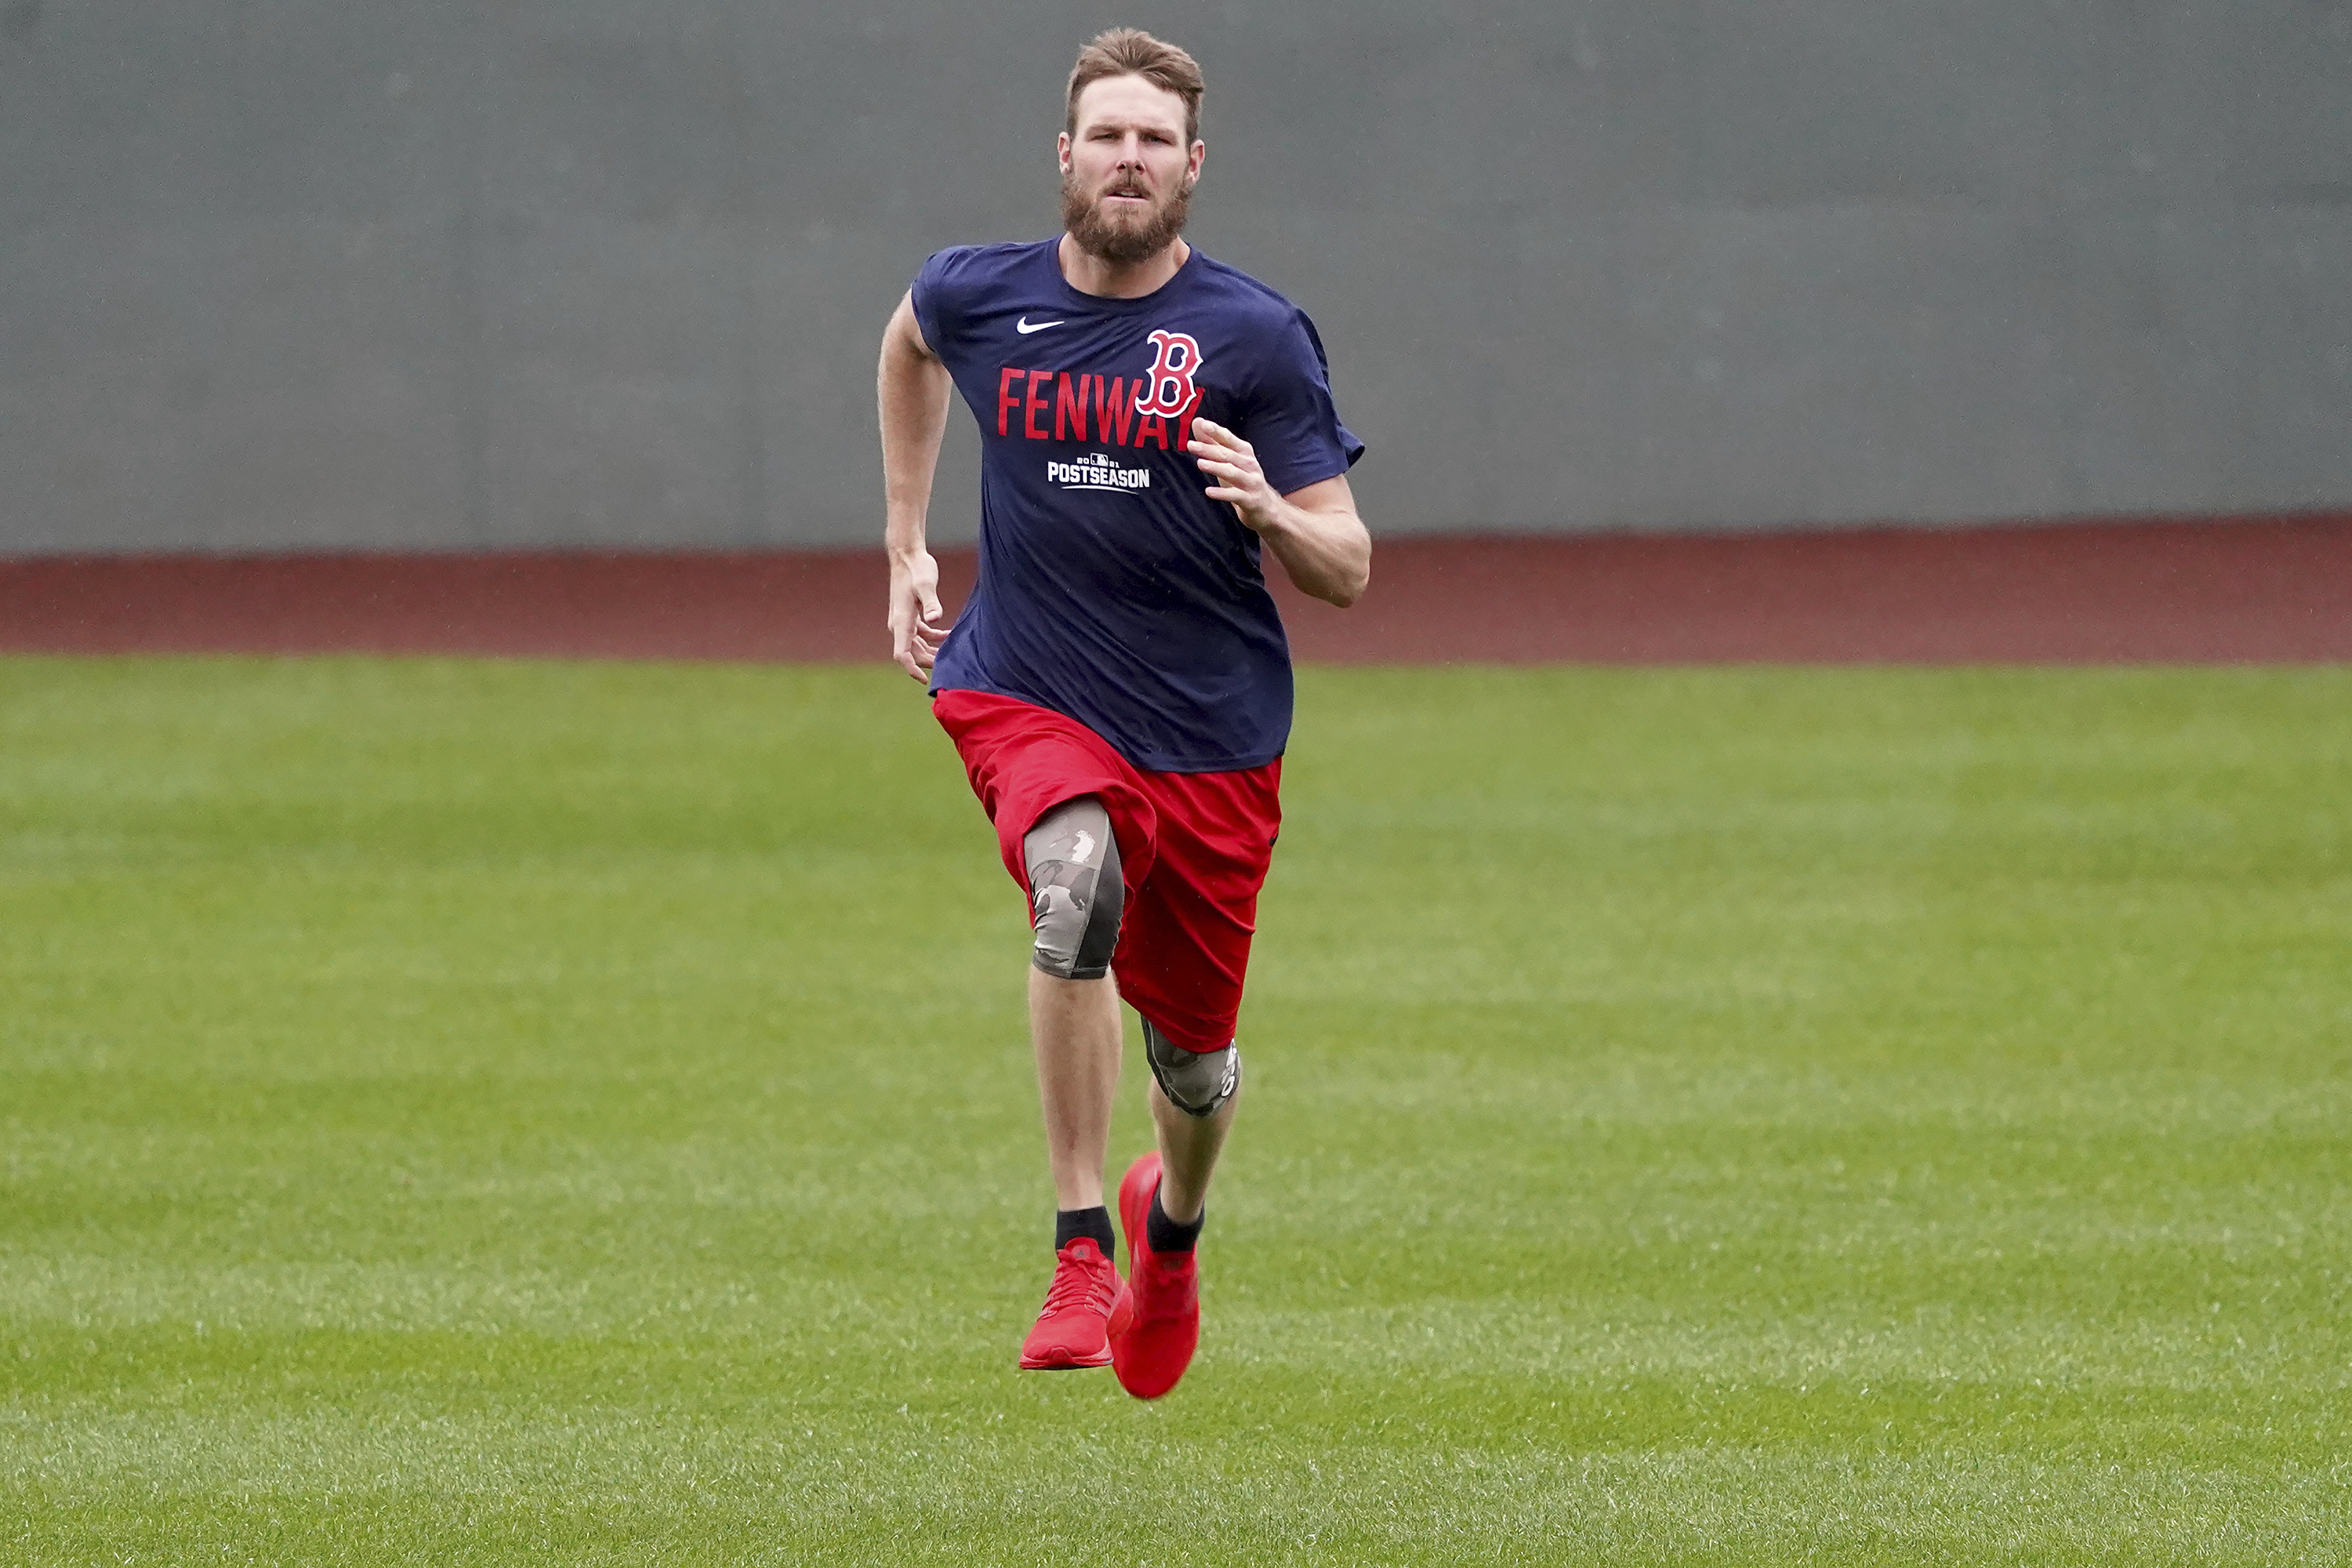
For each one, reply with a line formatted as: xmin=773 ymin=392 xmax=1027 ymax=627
xmin=880 ymin=28 xmax=1371 ymax=1399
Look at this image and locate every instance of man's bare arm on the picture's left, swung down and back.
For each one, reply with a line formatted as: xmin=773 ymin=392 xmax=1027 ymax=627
xmin=875 ymin=292 xmax=955 ymax=682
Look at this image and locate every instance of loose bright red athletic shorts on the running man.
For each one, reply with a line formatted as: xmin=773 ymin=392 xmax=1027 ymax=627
xmin=931 ymin=691 xmax=1282 ymax=1051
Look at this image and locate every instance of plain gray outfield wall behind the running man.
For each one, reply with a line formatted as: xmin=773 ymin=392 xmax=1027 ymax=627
xmin=0 ymin=0 xmax=2352 ymax=555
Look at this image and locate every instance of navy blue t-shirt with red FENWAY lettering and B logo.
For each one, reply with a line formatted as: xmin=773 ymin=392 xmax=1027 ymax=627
xmin=915 ymin=240 xmax=1364 ymax=774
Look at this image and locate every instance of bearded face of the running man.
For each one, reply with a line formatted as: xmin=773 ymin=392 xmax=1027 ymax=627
xmin=1061 ymin=75 xmax=1207 ymax=263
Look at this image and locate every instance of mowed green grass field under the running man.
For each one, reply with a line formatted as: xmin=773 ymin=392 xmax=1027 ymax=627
xmin=0 ymin=659 xmax=2352 ymax=1568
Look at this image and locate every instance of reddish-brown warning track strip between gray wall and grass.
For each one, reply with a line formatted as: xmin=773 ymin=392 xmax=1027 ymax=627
xmin=0 ymin=515 xmax=2352 ymax=663
